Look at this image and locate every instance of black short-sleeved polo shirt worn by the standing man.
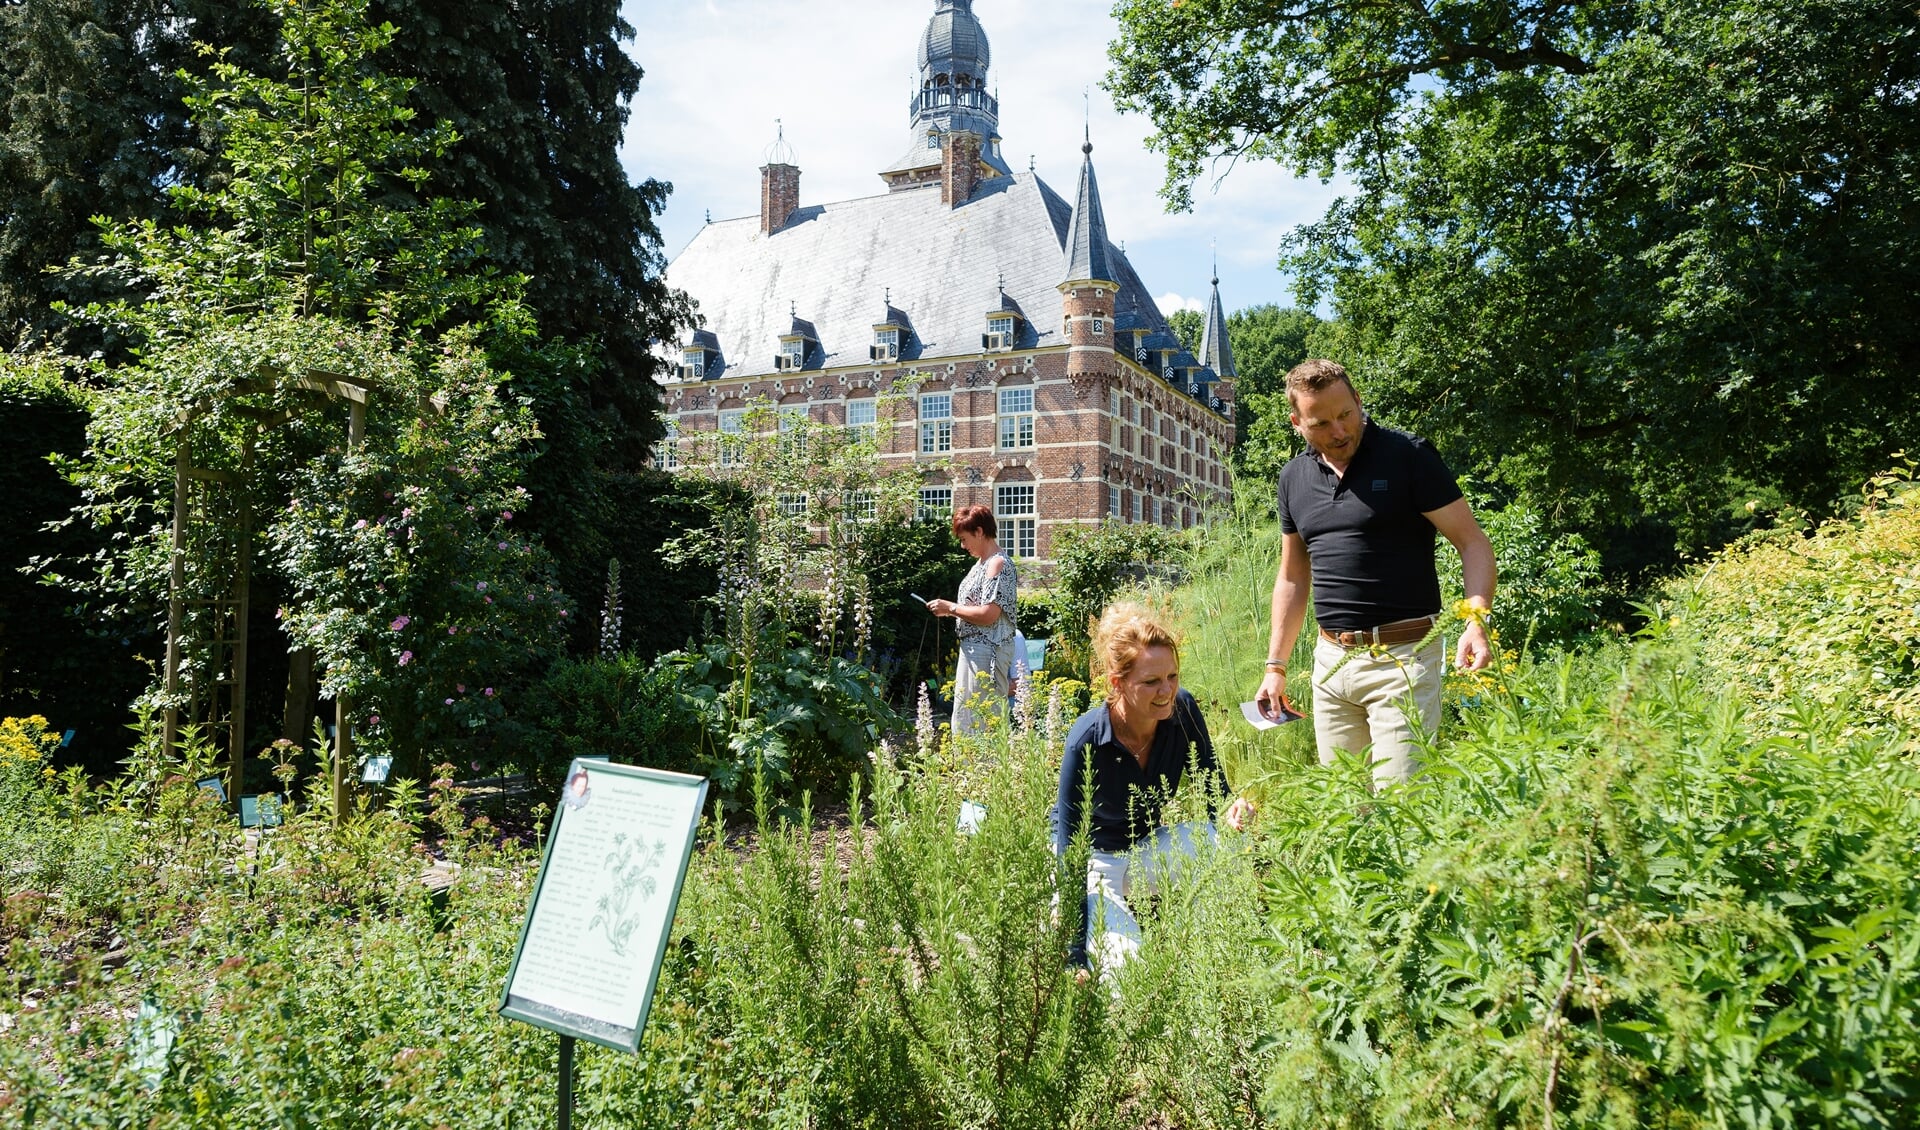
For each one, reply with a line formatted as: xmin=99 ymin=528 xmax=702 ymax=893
xmin=1279 ymin=420 xmax=1461 ymax=631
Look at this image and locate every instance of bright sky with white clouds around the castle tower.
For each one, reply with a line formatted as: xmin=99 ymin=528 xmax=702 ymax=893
xmin=620 ymin=0 xmax=1338 ymax=313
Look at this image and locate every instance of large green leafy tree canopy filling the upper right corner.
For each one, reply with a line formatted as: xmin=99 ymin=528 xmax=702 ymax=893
xmin=1108 ymin=0 xmax=1920 ymax=545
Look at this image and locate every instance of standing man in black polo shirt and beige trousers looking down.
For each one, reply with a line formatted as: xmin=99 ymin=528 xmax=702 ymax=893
xmin=1254 ymin=361 xmax=1494 ymax=785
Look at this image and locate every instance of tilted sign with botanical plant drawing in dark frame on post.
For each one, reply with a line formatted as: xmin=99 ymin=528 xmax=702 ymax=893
xmin=501 ymin=758 xmax=707 ymax=1051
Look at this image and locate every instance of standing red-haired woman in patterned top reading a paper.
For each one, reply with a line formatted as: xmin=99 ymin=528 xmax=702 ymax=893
xmin=927 ymin=505 xmax=1020 ymax=735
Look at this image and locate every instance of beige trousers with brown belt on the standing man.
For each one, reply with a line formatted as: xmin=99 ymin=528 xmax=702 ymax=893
xmin=1313 ymin=635 xmax=1446 ymax=787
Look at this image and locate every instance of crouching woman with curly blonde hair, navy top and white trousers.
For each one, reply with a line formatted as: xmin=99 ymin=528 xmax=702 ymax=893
xmin=1054 ymin=604 xmax=1252 ymax=971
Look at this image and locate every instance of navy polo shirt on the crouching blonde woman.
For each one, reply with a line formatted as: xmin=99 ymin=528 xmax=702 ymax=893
xmin=1054 ymin=691 xmax=1219 ymax=859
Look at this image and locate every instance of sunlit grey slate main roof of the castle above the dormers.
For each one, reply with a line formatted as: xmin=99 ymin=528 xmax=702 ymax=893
xmin=666 ymin=173 xmax=1171 ymax=380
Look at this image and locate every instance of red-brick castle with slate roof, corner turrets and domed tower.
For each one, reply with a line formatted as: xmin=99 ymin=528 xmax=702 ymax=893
xmin=657 ymin=0 xmax=1235 ymax=560
